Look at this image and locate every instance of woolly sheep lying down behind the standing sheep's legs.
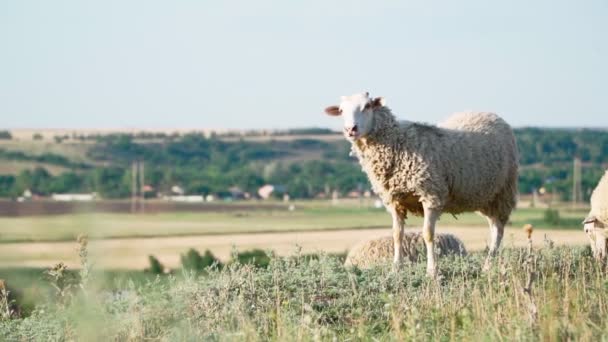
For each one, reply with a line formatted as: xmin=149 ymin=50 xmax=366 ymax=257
xmin=344 ymin=232 xmax=467 ymax=268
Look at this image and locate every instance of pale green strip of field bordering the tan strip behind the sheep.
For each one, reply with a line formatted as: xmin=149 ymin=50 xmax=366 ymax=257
xmin=0 ymin=206 xmax=586 ymax=243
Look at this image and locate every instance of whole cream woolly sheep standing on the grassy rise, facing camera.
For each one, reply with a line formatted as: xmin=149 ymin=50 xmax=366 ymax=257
xmin=325 ymin=93 xmax=518 ymax=276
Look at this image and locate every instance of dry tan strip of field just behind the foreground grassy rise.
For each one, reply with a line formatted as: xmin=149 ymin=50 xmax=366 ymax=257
xmin=0 ymin=227 xmax=587 ymax=269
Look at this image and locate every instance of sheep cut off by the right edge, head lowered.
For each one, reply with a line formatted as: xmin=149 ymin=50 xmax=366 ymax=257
xmin=583 ymin=171 xmax=608 ymax=260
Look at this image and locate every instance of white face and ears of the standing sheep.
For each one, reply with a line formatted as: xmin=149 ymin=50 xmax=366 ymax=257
xmin=325 ymin=92 xmax=384 ymax=142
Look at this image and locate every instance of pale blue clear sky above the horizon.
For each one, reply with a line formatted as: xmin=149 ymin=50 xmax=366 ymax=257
xmin=0 ymin=0 xmax=608 ymax=129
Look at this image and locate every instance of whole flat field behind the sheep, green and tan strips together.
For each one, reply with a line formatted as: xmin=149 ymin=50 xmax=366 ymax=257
xmin=0 ymin=201 xmax=587 ymax=269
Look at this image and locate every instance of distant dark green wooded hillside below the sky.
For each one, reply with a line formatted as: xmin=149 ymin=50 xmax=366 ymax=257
xmin=0 ymin=128 xmax=608 ymax=199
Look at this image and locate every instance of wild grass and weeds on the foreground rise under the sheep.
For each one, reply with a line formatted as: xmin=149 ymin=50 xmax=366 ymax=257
xmin=0 ymin=243 xmax=608 ymax=341
